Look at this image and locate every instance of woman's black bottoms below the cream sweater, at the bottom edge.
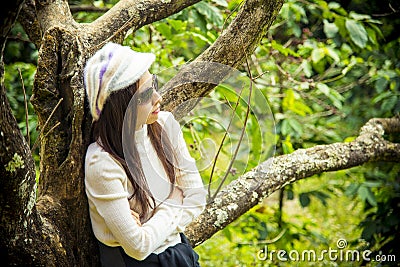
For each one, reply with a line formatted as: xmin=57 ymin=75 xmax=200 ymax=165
xmin=98 ymin=233 xmax=200 ymax=267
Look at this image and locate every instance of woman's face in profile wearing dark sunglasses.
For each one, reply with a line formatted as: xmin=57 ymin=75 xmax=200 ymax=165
xmin=136 ymin=71 xmax=162 ymax=130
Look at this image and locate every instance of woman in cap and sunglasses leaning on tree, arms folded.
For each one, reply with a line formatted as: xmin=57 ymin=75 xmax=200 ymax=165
xmin=84 ymin=43 xmax=206 ymax=267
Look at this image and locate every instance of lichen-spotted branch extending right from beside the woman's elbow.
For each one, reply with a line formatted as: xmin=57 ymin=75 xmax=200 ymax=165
xmin=186 ymin=116 xmax=400 ymax=246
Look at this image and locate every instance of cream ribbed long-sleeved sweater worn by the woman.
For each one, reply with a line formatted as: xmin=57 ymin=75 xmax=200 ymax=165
xmin=85 ymin=112 xmax=206 ymax=260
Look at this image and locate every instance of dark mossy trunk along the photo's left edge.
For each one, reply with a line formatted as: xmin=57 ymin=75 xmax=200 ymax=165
xmin=0 ymin=0 xmax=55 ymax=266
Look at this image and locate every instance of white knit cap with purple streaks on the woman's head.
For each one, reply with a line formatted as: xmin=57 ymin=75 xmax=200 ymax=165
xmin=84 ymin=42 xmax=155 ymax=121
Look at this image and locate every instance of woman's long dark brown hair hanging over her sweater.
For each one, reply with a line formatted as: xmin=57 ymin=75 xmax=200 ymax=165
xmin=92 ymin=83 xmax=176 ymax=222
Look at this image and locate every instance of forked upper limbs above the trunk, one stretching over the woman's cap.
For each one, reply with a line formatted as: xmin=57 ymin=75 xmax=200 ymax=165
xmin=19 ymin=0 xmax=200 ymax=49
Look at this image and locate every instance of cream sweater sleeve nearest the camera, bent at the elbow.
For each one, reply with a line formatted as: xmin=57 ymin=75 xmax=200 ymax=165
xmin=85 ymin=148 xmax=182 ymax=260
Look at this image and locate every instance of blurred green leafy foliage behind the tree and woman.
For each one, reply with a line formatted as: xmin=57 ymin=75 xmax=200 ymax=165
xmin=4 ymin=0 xmax=400 ymax=266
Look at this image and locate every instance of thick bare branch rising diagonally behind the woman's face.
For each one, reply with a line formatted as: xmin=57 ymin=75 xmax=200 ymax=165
xmin=163 ymin=0 xmax=284 ymax=118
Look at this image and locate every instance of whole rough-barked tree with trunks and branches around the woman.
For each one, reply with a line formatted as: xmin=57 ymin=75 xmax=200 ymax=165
xmin=0 ymin=0 xmax=400 ymax=266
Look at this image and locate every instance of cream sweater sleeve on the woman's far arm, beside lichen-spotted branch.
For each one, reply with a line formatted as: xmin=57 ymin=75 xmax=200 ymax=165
xmin=161 ymin=113 xmax=207 ymax=232
